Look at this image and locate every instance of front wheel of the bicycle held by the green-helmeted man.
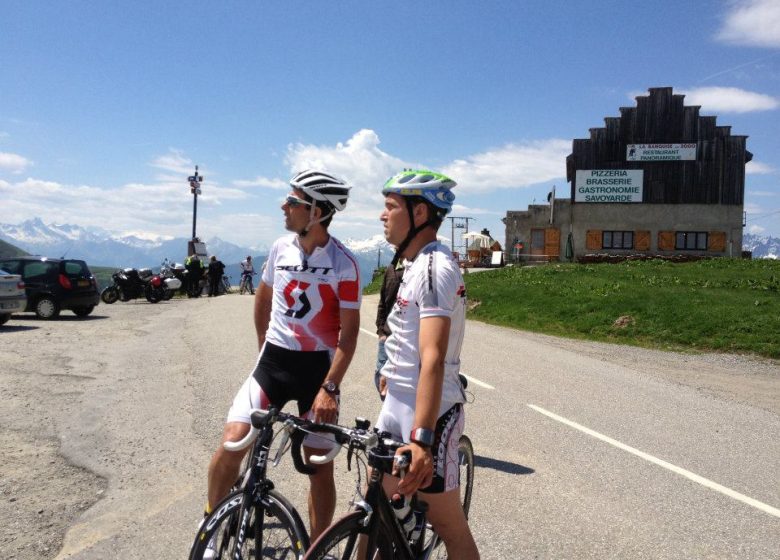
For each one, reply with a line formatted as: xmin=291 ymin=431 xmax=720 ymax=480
xmin=305 ymin=511 xmax=393 ymax=560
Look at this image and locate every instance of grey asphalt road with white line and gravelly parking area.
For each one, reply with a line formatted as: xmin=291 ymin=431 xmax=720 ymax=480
xmin=0 ymin=295 xmax=780 ymax=560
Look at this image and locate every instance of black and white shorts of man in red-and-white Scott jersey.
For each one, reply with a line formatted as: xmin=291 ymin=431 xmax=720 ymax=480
xmin=227 ymin=342 xmax=338 ymax=450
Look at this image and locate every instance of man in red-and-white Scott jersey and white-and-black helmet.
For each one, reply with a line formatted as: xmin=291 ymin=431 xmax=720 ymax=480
xmin=204 ymin=170 xmax=360 ymax=544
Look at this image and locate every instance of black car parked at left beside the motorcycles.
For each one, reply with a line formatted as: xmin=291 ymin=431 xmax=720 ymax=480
xmin=0 ymin=257 xmax=100 ymax=319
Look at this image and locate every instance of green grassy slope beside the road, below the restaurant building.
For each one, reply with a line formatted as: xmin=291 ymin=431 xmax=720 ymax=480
xmin=464 ymin=259 xmax=780 ymax=358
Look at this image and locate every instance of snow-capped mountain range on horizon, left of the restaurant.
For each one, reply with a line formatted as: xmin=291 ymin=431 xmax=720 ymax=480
xmin=0 ymin=218 xmax=393 ymax=284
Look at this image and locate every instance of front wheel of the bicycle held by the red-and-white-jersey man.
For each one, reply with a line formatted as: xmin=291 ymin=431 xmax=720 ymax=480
xmin=190 ymin=490 xmax=309 ymax=560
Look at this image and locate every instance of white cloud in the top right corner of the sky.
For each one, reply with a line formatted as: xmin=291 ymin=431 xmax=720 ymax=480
xmin=717 ymin=0 xmax=780 ymax=48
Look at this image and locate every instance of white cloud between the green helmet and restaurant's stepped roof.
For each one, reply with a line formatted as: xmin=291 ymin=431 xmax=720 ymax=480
xmin=443 ymin=139 xmax=571 ymax=193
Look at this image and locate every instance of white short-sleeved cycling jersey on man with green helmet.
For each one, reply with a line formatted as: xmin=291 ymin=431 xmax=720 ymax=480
xmin=382 ymin=241 xmax=466 ymax=405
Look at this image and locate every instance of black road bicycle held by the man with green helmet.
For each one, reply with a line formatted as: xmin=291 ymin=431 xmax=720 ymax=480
xmin=304 ymin=420 xmax=474 ymax=560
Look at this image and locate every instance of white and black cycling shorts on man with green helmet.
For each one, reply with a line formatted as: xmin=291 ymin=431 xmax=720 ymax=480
xmin=376 ymin=391 xmax=466 ymax=494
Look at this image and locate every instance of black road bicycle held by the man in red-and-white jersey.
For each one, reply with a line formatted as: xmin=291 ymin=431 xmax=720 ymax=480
xmin=189 ymin=408 xmax=316 ymax=560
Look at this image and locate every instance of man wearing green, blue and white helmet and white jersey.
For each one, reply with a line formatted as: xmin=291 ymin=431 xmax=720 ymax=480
xmin=376 ymin=170 xmax=479 ymax=559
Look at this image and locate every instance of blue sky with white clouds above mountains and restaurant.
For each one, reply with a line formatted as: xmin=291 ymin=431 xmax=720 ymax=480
xmin=0 ymin=0 xmax=780 ymax=248
